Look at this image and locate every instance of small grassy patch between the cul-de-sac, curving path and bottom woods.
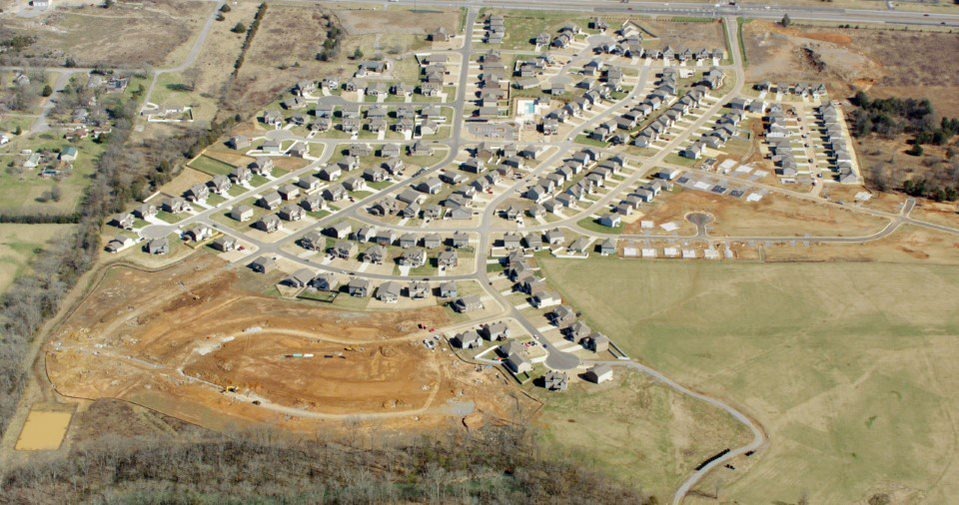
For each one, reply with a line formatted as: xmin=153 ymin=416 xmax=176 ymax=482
xmin=541 ymin=369 xmax=751 ymax=503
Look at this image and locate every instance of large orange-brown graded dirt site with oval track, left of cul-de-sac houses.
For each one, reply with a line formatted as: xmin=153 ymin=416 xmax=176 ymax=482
xmin=46 ymin=254 xmax=531 ymax=431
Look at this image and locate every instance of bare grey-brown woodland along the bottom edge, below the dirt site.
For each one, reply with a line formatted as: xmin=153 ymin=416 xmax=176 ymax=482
xmin=2 ymin=428 xmax=657 ymax=505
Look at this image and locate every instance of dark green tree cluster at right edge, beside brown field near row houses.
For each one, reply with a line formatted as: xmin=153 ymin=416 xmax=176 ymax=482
xmin=852 ymin=91 xmax=959 ymax=145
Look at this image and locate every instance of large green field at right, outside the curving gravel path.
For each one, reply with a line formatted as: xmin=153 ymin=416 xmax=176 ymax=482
xmin=540 ymin=258 xmax=959 ymax=503
